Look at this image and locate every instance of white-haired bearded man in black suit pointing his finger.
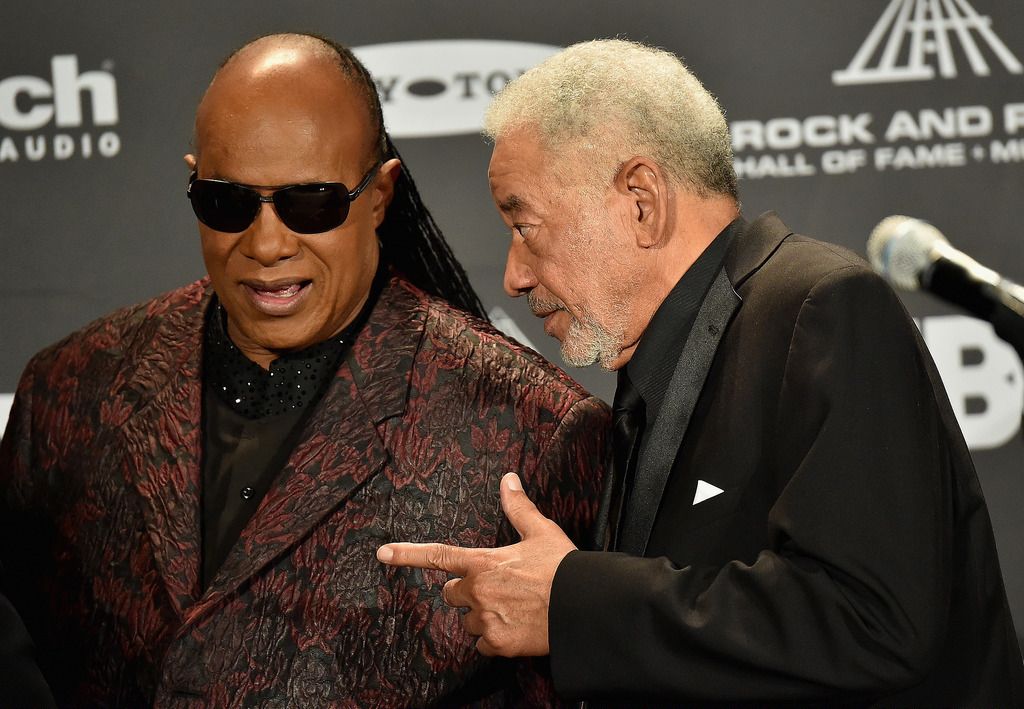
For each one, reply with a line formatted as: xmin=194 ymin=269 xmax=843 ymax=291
xmin=378 ymin=40 xmax=1024 ymax=707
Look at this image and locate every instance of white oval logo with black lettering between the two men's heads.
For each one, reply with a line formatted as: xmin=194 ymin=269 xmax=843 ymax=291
xmin=352 ymin=39 xmax=561 ymax=138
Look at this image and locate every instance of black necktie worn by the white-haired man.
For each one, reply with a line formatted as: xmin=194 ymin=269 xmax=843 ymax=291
xmin=608 ymin=367 xmax=646 ymax=551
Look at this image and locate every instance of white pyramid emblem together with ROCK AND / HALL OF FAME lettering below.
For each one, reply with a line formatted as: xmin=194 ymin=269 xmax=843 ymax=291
xmin=730 ymin=0 xmax=1024 ymax=179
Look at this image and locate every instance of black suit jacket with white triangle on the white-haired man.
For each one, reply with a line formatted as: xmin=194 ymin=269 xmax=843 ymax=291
xmin=550 ymin=214 xmax=1024 ymax=707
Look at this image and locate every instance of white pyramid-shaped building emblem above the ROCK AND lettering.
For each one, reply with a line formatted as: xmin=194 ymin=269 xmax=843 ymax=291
xmin=833 ymin=0 xmax=1024 ymax=86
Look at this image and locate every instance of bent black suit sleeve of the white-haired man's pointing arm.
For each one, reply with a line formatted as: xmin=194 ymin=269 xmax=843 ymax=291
xmin=549 ymin=267 xmax=962 ymax=701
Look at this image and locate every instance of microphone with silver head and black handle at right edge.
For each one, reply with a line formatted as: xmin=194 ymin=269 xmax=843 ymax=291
xmin=867 ymin=215 xmax=1024 ymax=357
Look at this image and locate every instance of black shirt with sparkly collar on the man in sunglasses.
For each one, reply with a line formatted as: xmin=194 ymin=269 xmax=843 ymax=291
xmin=202 ymin=268 xmax=386 ymax=588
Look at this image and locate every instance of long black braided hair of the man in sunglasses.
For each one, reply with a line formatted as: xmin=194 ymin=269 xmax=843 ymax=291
xmin=221 ymin=32 xmax=487 ymax=320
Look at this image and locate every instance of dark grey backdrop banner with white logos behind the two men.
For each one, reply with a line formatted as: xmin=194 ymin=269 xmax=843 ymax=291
xmin=6 ymin=0 xmax=1024 ymax=643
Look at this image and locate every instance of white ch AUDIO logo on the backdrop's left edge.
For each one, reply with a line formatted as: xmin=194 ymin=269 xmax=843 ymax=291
xmin=0 ymin=54 xmax=121 ymax=163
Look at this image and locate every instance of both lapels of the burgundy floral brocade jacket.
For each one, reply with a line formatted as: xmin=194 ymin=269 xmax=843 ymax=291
xmin=120 ymin=276 xmax=426 ymax=623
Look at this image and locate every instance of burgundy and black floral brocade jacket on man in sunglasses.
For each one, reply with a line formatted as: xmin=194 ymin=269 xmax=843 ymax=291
xmin=0 ymin=278 xmax=608 ymax=708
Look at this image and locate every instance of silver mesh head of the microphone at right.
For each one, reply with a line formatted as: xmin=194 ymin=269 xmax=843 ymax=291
xmin=867 ymin=215 xmax=949 ymax=291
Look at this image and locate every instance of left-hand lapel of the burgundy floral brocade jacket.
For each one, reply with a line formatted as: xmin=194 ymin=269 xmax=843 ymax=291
xmin=117 ymin=282 xmax=210 ymax=617
